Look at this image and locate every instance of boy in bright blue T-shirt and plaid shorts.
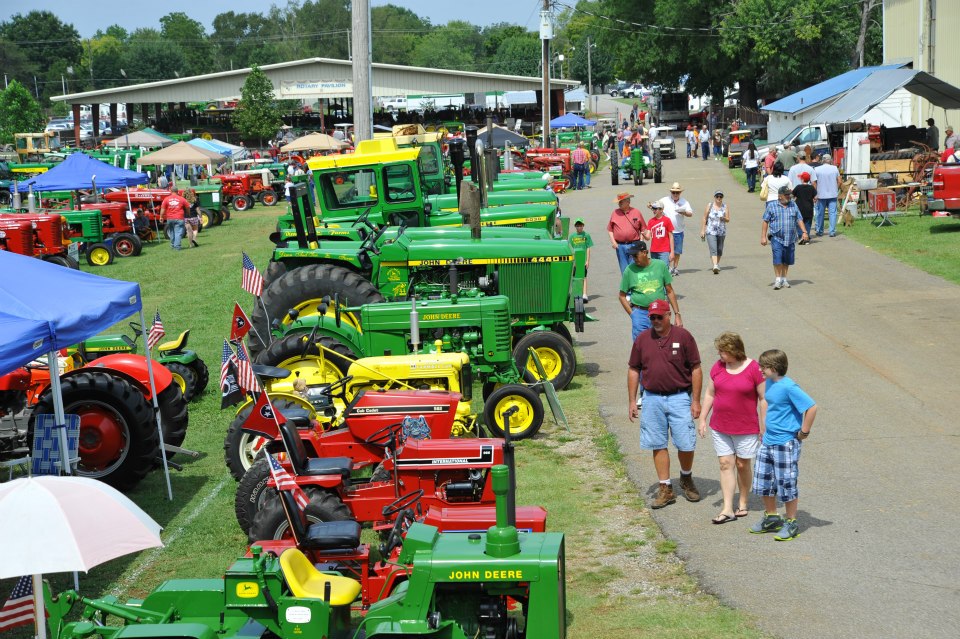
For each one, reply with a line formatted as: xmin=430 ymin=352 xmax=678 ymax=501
xmin=750 ymin=349 xmax=817 ymax=541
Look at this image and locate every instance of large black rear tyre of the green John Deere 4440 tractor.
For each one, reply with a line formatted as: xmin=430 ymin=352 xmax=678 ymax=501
xmin=250 ymin=264 xmax=384 ymax=357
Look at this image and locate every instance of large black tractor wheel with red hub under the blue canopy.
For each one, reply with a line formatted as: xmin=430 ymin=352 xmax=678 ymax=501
xmin=30 ymin=371 xmax=160 ymax=491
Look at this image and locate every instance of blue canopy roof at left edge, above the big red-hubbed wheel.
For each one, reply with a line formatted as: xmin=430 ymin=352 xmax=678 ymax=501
xmin=0 ymin=251 xmax=142 ymax=375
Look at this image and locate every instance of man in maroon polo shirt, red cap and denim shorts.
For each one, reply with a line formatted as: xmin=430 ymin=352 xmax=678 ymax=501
xmin=627 ymin=300 xmax=703 ymax=508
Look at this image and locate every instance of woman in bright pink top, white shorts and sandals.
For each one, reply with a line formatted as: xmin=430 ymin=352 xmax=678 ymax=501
xmin=697 ymin=332 xmax=767 ymax=524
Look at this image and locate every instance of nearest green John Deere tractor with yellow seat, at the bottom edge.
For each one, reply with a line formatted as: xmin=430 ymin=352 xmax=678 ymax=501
xmin=44 ymin=466 xmax=567 ymax=639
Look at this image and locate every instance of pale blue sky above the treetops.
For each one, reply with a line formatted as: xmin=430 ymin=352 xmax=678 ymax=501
xmin=22 ymin=0 xmax=542 ymax=38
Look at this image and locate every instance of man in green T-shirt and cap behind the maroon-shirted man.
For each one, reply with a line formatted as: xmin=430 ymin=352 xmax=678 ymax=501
xmin=620 ymin=240 xmax=683 ymax=341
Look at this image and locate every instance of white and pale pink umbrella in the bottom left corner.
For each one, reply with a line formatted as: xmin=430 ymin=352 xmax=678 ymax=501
xmin=0 ymin=476 xmax=163 ymax=639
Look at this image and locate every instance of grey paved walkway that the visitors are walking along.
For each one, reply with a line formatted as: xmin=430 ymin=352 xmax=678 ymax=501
xmin=561 ymin=154 xmax=960 ymax=638
